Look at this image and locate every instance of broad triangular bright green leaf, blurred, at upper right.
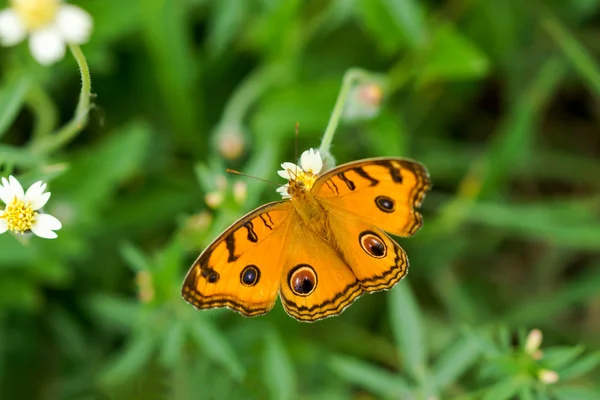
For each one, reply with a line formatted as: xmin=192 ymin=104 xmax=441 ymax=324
xmin=417 ymin=24 xmax=490 ymax=85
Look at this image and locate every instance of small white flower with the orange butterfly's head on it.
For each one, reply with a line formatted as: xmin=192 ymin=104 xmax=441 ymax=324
xmin=277 ymin=149 xmax=323 ymax=199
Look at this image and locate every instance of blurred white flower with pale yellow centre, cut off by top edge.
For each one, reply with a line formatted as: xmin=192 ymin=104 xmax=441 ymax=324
xmin=0 ymin=0 xmax=93 ymax=65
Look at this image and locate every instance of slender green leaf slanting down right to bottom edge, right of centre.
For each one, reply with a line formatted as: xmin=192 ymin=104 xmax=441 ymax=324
xmin=327 ymin=356 xmax=414 ymax=399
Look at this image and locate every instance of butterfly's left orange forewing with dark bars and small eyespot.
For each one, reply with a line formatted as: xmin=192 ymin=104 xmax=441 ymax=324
xmin=181 ymin=201 xmax=293 ymax=316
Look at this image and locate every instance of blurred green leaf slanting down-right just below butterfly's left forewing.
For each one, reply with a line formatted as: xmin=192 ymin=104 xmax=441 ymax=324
xmin=190 ymin=318 xmax=244 ymax=380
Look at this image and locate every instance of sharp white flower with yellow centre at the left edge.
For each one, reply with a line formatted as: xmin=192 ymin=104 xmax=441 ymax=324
xmin=0 ymin=176 xmax=62 ymax=239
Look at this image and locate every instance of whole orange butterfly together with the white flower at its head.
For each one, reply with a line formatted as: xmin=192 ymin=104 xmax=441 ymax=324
xmin=181 ymin=149 xmax=431 ymax=322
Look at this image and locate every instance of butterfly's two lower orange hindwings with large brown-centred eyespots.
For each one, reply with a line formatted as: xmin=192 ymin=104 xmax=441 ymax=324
xmin=280 ymin=211 xmax=408 ymax=322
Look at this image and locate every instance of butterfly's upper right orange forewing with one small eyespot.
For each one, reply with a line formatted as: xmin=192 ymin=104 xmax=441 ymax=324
xmin=312 ymin=158 xmax=431 ymax=236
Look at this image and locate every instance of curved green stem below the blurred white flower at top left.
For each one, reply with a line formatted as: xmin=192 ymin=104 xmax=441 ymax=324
xmin=32 ymin=44 xmax=92 ymax=154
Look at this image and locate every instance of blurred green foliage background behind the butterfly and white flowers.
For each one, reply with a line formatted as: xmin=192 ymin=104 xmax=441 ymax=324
xmin=0 ymin=0 xmax=600 ymax=400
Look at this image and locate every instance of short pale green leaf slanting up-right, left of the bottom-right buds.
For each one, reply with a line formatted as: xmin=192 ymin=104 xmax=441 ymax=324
xmin=432 ymin=336 xmax=481 ymax=391
